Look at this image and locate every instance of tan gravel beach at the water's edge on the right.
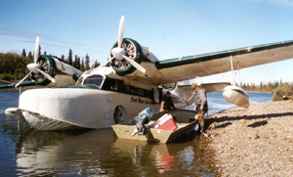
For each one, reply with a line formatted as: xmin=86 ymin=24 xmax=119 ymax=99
xmin=207 ymin=101 xmax=293 ymax=177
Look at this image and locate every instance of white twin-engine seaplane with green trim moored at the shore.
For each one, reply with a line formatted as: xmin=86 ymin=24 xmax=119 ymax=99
xmin=0 ymin=16 xmax=293 ymax=130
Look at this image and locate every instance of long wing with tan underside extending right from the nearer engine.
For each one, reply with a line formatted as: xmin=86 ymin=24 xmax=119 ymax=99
xmin=156 ymin=41 xmax=293 ymax=83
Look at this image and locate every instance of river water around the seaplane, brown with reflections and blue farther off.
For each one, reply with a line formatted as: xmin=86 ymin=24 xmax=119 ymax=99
xmin=0 ymin=92 xmax=271 ymax=177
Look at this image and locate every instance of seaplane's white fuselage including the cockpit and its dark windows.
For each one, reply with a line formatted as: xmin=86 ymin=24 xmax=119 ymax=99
xmin=18 ymin=65 xmax=158 ymax=130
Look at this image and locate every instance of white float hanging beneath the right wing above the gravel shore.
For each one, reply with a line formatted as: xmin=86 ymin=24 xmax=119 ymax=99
xmin=223 ymin=85 xmax=249 ymax=108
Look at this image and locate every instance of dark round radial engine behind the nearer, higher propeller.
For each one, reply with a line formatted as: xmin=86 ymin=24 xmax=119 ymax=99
xmin=111 ymin=38 xmax=142 ymax=76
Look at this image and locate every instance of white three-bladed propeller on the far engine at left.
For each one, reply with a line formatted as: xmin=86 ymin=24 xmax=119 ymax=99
xmin=15 ymin=36 xmax=56 ymax=88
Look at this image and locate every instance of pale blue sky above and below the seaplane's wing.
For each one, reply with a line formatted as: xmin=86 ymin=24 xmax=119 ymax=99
xmin=0 ymin=0 xmax=293 ymax=82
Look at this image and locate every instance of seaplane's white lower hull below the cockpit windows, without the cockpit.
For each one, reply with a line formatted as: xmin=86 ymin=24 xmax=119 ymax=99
xmin=19 ymin=88 xmax=155 ymax=130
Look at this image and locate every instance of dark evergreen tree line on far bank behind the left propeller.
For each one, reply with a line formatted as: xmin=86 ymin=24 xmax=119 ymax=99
xmin=0 ymin=49 xmax=100 ymax=81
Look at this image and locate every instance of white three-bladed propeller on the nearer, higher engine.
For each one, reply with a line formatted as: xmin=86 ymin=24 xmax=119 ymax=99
xmin=110 ymin=16 xmax=146 ymax=75
